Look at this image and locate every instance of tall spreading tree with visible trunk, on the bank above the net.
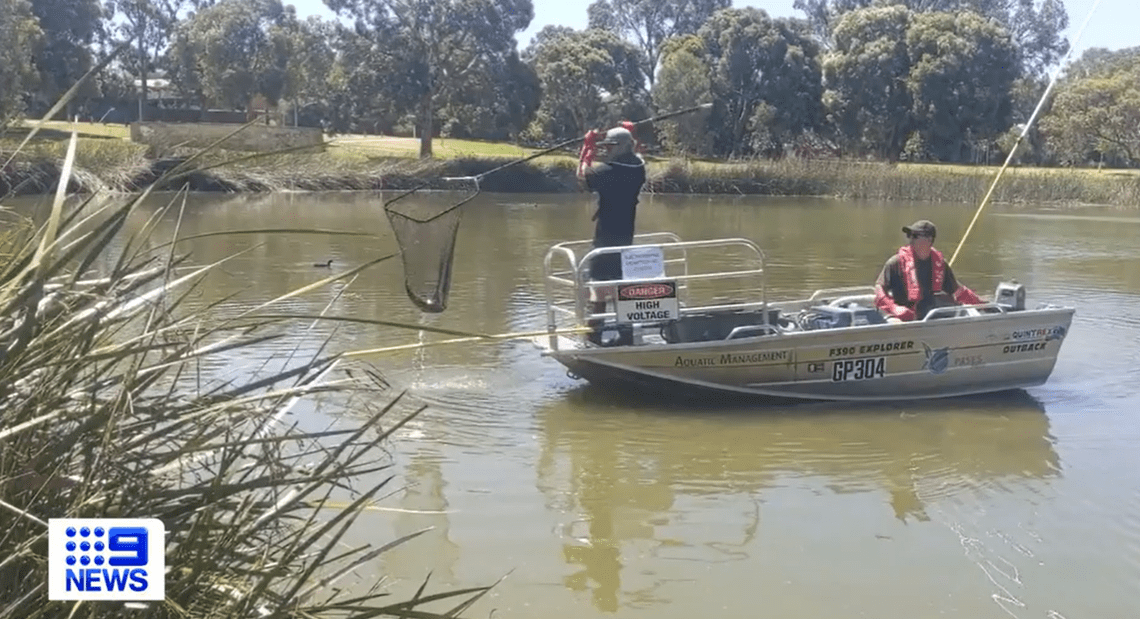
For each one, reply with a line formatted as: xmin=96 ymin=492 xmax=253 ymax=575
xmin=325 ymin=0 xmax=535 ymax=157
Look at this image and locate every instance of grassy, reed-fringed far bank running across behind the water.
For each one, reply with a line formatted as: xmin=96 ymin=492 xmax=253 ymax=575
xmin=0 ymin=138 xmax=1140 ymax=207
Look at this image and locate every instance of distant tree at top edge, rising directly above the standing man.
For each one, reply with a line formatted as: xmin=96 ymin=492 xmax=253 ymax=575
xmin=586 ymin=0 xmax=732 ymax=87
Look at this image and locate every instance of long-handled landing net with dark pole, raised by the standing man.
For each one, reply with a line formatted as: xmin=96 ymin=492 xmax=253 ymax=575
xmin=384 ymin=103 xmax=713 ymax=313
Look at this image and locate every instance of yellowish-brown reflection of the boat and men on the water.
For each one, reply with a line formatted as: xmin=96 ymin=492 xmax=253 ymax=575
xmin=537 ymin=388 xmax=1060 ymax=612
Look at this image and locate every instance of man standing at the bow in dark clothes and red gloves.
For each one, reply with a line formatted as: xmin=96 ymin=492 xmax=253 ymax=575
xmin=578 ymin=123 xmax=645 ymax=344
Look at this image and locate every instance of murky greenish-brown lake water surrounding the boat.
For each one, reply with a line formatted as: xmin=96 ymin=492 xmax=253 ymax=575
xmin=11 ymin=194 xmax=1140 ymax=619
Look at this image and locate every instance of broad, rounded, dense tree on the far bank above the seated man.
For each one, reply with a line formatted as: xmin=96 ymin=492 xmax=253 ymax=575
xmin=823 ymin=5 xmax=1019 ymax=161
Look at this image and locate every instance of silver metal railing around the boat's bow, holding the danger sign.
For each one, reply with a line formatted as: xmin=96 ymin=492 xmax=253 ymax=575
xmin=544 ymin=233 xmax=767 ymax=350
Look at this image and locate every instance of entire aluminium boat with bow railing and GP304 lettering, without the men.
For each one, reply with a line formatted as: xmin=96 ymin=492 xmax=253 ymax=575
xmin=535 ymin=233 xmax=1075 ymax=401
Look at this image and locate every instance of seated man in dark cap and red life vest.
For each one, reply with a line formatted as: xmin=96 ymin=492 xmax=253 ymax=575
xmin=874 ymin=219 xmax=983 ymax=323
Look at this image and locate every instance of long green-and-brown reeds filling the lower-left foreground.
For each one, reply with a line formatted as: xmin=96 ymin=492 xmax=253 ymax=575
xmin=0 ymin=54 xmax=501 ymax=619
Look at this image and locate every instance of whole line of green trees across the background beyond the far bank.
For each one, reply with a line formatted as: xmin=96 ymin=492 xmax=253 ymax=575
xmin=0 ymin=0 xmax=1121 ymax=169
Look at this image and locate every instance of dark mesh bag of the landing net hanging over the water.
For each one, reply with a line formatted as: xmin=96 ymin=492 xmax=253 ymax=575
xmin=384 ymin=178 xmax=479 ymax=313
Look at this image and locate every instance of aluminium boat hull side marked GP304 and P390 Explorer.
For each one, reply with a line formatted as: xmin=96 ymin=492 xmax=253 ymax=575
xmin=536 ymin=308 xmax=1074 ymax=404
